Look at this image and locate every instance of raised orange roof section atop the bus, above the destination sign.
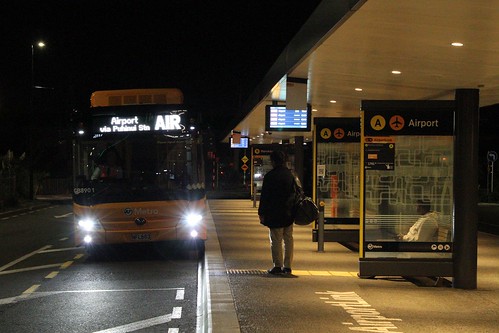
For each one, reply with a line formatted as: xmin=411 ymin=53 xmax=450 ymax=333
xmin=90 ymin=88 xmax=184 ymax=107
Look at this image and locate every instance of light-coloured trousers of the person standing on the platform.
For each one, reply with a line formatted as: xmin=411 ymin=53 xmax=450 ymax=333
xmin=269 ymin=225 xmax=294 ymax=268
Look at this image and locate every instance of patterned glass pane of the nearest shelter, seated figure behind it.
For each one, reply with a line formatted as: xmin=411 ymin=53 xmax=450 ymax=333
xmin=364 ymin=136 xmax=454 ymax=258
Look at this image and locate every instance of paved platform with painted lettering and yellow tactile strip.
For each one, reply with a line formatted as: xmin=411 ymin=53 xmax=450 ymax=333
xmin=205 ymin=199 xmax=499 ymax=333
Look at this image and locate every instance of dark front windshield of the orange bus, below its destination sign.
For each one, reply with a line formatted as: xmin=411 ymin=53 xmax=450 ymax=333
xmin=75 ymin=134 xmax=204 ymax=205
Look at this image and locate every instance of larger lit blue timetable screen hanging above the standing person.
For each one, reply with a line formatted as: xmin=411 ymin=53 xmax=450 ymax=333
xmin=265 ymin=105 xmax=311 ymax=132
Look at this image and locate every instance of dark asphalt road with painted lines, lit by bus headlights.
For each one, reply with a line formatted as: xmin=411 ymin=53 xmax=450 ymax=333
xmin=0 ymin=205 xmax=198 ymax=333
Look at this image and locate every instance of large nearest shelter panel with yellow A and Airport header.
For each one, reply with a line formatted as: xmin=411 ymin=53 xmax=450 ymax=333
xmin=359 ymin=101 xmax=455 ymax=277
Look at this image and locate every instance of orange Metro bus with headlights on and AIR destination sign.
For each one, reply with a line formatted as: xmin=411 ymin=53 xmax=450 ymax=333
xmin=73 ymin=89 xmax=206 ymax=253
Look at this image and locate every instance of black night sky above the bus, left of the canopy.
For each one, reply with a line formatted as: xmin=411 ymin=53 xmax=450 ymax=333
xmin=0 ymin=0 xmax=320 ymax=154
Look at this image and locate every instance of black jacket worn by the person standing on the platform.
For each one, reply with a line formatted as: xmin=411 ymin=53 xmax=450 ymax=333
xmin=258 ymin=166 xmax=294 ymax=228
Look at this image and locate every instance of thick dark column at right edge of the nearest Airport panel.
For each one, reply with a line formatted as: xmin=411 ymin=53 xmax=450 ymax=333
xmin=453 ymin=89 xmax=480 ymax=289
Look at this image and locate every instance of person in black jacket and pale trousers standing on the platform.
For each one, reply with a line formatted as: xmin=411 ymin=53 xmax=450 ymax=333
xmin=258 ymin=151 xmax=294 ymax=274
